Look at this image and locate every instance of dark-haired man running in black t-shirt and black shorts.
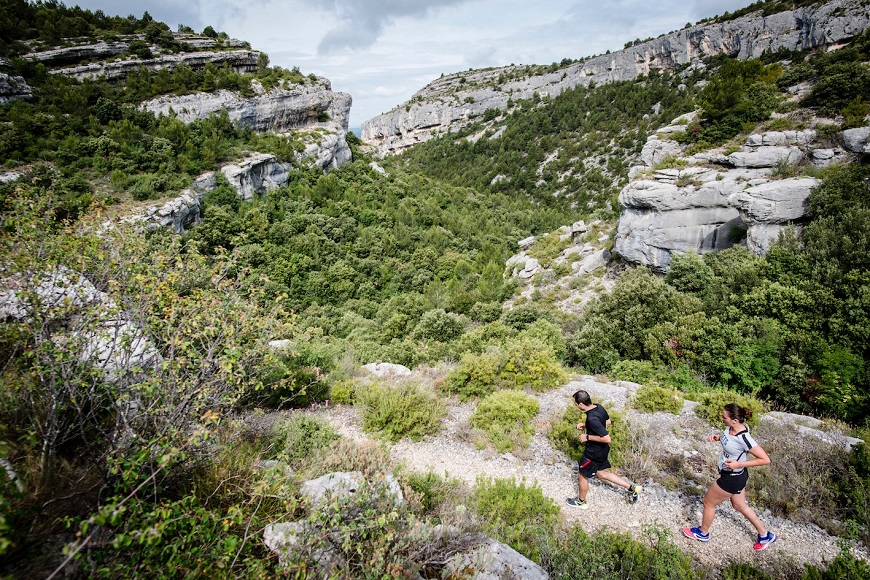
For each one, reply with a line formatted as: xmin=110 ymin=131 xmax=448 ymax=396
xmin=565 ymin=391 xmax=641 ymax=510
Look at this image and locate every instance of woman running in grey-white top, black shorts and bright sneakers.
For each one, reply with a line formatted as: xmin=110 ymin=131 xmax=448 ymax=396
xmin=683 ymin=403 xmax=778 ymax=551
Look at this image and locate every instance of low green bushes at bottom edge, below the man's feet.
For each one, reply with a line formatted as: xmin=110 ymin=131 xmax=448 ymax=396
xmin=540 ymin=525 xmax=698 ymax=580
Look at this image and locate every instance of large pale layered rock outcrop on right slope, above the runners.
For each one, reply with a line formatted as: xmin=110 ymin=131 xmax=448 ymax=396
xmin=615 ymin=119 xmax=851 ymax=272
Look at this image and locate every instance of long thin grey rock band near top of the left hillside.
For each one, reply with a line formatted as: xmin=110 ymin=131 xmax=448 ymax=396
xmin=49 ymin=50 xmax=260 ymax=81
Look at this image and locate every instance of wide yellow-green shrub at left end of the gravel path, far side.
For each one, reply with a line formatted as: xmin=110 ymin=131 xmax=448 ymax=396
xmin=357 ymin=383 xmax=446 ymax=441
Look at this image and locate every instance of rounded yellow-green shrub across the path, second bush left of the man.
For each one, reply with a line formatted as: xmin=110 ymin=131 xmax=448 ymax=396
xmin=469 ymin=390 xmax=541 ymax=453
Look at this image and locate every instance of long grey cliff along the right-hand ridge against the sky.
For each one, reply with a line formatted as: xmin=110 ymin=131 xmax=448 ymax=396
xmin=362 ymin=0 xmax=870 ymax=155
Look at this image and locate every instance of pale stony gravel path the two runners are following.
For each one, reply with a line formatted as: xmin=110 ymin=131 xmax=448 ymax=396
xmin=321 ymin=377 xmax=868 ymax=566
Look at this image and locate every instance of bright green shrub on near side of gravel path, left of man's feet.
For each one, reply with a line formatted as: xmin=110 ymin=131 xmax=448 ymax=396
xmin=469 ymin=476 xmax=560 ymax=560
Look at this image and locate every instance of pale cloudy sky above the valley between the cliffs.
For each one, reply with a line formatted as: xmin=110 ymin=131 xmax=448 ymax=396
xmin=65 ymin=0 xmax=752 ymax=127
